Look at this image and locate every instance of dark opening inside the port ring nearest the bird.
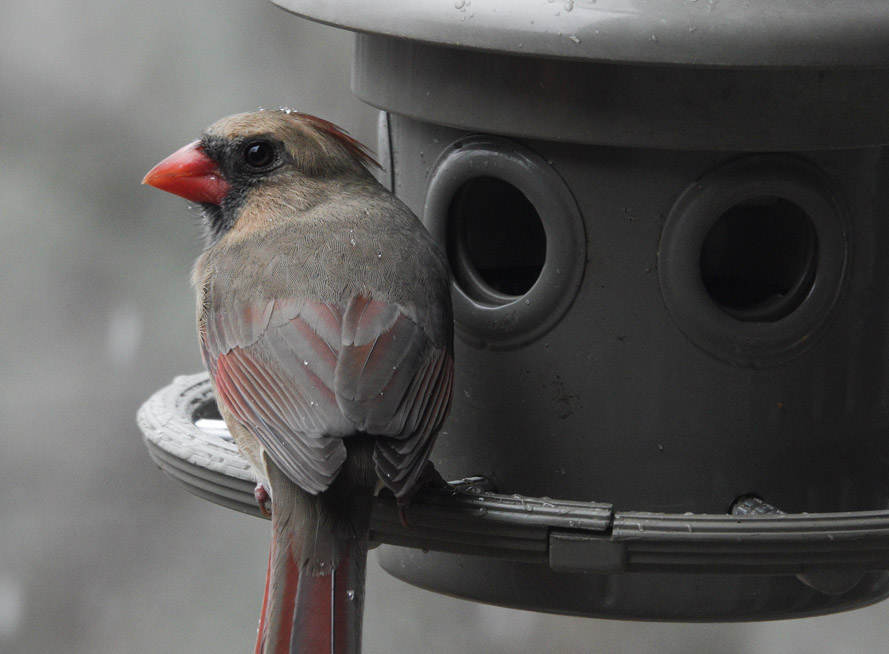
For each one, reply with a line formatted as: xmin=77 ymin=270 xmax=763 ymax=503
xmin=447 ymin=177 xmax=546 ymax=305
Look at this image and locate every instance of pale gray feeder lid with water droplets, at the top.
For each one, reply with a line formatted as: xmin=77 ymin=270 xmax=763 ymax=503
xmin=272 ymin=0 xmax=889 ymax=68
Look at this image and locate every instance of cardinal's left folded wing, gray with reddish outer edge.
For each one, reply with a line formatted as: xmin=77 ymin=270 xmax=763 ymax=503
xmin=202 ymin=298 xmax=354 ymax=493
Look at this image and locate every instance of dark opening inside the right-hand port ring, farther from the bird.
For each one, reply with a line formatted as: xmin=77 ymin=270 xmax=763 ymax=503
xmin=700 ymin=196 xmax=818 ymax=322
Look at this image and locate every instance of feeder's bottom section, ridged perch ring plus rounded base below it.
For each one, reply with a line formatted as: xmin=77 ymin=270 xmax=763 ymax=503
xmin=138 ymin=374 xmax=889 ymax=622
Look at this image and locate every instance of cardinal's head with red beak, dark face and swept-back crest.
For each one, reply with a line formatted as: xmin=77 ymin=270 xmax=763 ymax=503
xmin=142 ymin=109 xmax=378 ymax=243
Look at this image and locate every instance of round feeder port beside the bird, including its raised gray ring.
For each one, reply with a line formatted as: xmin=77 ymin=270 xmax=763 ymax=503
xmin=423 ymin=136 xmax=586 ymax=350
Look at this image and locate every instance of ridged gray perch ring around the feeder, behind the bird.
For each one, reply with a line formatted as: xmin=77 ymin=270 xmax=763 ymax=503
xmin=137 ymin=373 xmax=889 ymax=575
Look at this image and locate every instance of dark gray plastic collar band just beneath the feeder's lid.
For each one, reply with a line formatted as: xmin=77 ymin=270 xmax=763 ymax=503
xmin=352 ymin=37 xmax=889 ymax=151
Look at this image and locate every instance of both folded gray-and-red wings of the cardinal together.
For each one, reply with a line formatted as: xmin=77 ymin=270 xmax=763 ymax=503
xmin=202 ymin=296 xmax=453 ymax=493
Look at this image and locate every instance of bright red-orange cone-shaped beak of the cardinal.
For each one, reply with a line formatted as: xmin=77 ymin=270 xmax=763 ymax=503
xmin=142 ymin=141 xmax=231 ymax=204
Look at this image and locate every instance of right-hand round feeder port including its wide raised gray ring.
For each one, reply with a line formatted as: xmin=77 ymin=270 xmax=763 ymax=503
xmin=658 ymin=155 xmax=847 ymax=367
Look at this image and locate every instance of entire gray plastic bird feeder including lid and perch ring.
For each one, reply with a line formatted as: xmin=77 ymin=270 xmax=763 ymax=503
xmin=140 ymin=0 xmax=889 ymax=621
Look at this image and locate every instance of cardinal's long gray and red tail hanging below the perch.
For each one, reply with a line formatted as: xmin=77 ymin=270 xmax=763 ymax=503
xmin=256 ymin=462 xmax=373 ymax=654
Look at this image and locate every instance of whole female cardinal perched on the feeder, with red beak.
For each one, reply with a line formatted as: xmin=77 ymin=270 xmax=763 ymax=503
xmin=143 ymin=110 xmax=453 ymax=654
